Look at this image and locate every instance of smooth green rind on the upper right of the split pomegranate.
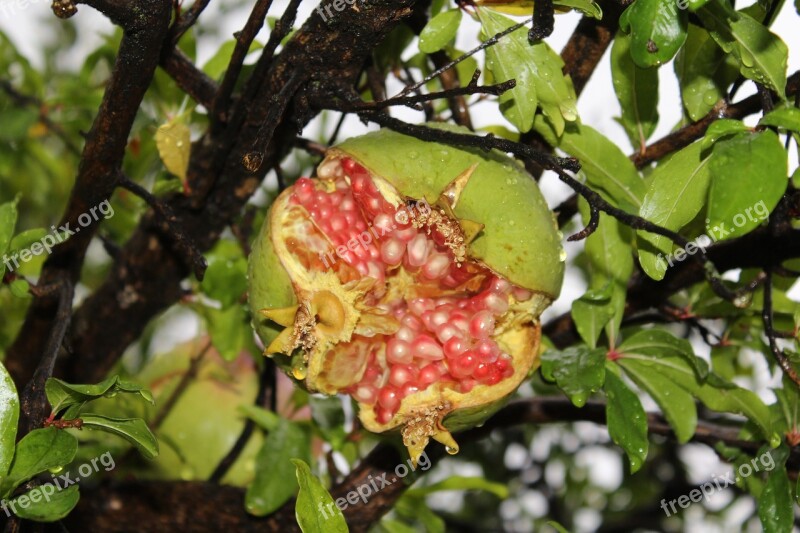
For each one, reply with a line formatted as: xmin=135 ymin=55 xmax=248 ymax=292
xmin=323 ymin=123 xmax=564 ymax=305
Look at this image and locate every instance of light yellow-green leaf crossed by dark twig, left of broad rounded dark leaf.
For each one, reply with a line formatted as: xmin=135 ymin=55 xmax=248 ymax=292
xmin=637 ymin=143 xmax=711 ymax=280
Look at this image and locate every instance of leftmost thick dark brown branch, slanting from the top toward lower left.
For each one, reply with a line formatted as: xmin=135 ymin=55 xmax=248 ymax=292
xmin=6 ymin=0 xmax=171 ymax=384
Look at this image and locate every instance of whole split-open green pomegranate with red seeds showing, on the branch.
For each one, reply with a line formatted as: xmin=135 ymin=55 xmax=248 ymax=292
xmin=250 ymin=126 xmax=563 ymax=460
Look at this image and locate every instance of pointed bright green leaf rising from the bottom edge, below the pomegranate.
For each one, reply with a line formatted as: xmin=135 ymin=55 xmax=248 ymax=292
xmin=292 ymin=459 xmax=349 ymax=533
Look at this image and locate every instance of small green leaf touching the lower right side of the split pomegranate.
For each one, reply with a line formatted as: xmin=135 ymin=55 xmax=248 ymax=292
xmin=542 ymin=346 xmax=606 ymax=407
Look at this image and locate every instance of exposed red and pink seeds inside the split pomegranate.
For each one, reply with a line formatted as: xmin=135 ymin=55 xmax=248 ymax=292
xmin=284 ymin=159 xmax=532 ymax=424
